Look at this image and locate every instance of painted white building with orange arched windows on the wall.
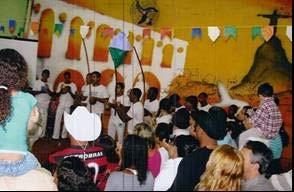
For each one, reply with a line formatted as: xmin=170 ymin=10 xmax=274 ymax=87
xmin=31 ymin=0 xmax=188 ymax=100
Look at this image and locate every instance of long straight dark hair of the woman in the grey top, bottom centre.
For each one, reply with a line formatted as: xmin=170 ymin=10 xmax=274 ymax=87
xmin=121 ymin=135 xmax=148 ymax=185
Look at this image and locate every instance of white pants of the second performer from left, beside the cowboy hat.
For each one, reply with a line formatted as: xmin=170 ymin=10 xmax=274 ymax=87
xmin=52 ymin=105 xmax=70 ymax=139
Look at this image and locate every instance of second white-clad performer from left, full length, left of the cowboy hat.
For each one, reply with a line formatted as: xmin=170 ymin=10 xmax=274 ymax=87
xmin=52 ymin=72 xmax=77 ymax=139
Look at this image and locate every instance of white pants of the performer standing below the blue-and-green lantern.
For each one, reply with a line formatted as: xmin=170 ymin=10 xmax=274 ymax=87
xmin=108 ymin=117 xmax=125 ymax=144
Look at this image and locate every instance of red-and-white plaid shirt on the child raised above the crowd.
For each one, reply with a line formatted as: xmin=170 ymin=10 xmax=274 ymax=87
xmin=250 ymin=97 xmax=283 ymax=139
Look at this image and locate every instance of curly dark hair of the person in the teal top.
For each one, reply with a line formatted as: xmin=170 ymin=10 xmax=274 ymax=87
xmin=0 ymin=49 xmax=28 ymax=127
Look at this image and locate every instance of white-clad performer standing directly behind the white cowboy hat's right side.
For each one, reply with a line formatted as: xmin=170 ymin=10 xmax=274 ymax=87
xmin=86 ymin=71 xmax=109 ymax=118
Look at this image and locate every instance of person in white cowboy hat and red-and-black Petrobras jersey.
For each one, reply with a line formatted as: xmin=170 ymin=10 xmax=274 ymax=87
xmin=49 ymin=106 xmax=108 ymax=188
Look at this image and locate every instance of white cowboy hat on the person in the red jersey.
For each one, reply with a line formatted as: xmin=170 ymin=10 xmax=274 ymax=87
xmin=64 ymin=106 xmax=101 ymax=141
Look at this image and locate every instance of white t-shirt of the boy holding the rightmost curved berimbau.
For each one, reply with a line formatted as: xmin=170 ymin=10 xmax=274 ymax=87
xmin=127 ymin=101 xmax=144 ymax=134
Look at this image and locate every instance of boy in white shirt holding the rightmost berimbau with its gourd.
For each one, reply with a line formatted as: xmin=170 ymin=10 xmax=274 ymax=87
xmin=116 ymin=88 xmax=144 ymax=134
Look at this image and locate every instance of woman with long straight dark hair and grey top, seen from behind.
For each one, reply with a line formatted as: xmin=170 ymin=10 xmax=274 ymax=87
xmin=105 ymin=135 xmax=154 ymax=191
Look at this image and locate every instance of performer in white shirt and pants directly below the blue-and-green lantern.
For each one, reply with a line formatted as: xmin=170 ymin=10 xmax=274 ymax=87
xmin=106 ymin=82 xmax=130 ymax=144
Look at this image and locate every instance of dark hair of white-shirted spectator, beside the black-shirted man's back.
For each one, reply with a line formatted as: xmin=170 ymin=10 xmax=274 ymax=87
xmin=174 ymin=135 xmax=199 ymax=157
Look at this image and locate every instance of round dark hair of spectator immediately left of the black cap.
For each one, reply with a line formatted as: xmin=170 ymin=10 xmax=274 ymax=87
xmin=172 ymin=108 xmax=190 ymax=129
